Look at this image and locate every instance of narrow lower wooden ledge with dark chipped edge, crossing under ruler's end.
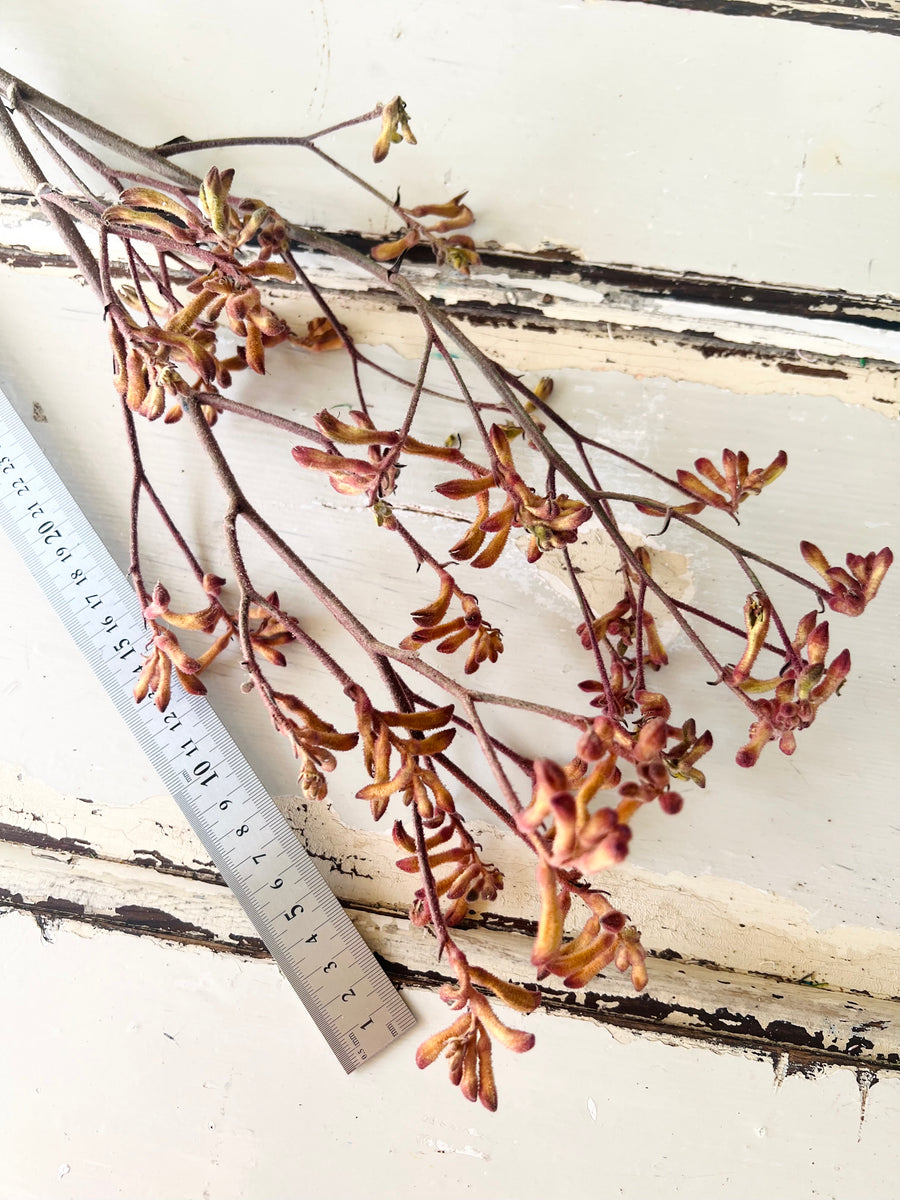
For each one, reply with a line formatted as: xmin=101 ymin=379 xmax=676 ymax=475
xmin=0 ymin=841 xmax=900 ymax=1069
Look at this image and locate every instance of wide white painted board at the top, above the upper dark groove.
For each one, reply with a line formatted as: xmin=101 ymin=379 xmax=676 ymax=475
xmin=0 ymin=0 xmax=900 ymax=294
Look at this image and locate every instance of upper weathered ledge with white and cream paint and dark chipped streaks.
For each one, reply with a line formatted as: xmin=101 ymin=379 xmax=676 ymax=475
xmin=0 ymin=192 xmax=900 ymax=416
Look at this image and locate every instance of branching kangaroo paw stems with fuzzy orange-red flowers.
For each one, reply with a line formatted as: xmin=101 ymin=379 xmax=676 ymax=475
xmin=0 ymin=70 xmax=892 ymax=1109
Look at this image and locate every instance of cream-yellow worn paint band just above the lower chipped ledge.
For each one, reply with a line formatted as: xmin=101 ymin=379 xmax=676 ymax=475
xmin=0 ymin=768 xmax=900 ymax=998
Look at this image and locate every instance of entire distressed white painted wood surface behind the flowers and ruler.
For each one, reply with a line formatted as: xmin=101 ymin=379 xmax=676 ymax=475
xmin=0 ymin=0 xmax=900 ymax=1200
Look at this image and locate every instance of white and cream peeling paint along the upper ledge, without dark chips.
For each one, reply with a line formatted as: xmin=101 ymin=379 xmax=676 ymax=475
xmin=0 ymin=197 xmax=900 ymax=416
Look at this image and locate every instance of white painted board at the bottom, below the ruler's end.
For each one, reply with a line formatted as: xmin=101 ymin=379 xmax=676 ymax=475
xmin=0 ymin=914 xmax=900 ymax=1200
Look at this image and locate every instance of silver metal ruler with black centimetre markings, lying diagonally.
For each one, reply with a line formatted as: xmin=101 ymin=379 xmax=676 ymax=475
xmin=0 ymin=390 xmax=415 ymax=1072
